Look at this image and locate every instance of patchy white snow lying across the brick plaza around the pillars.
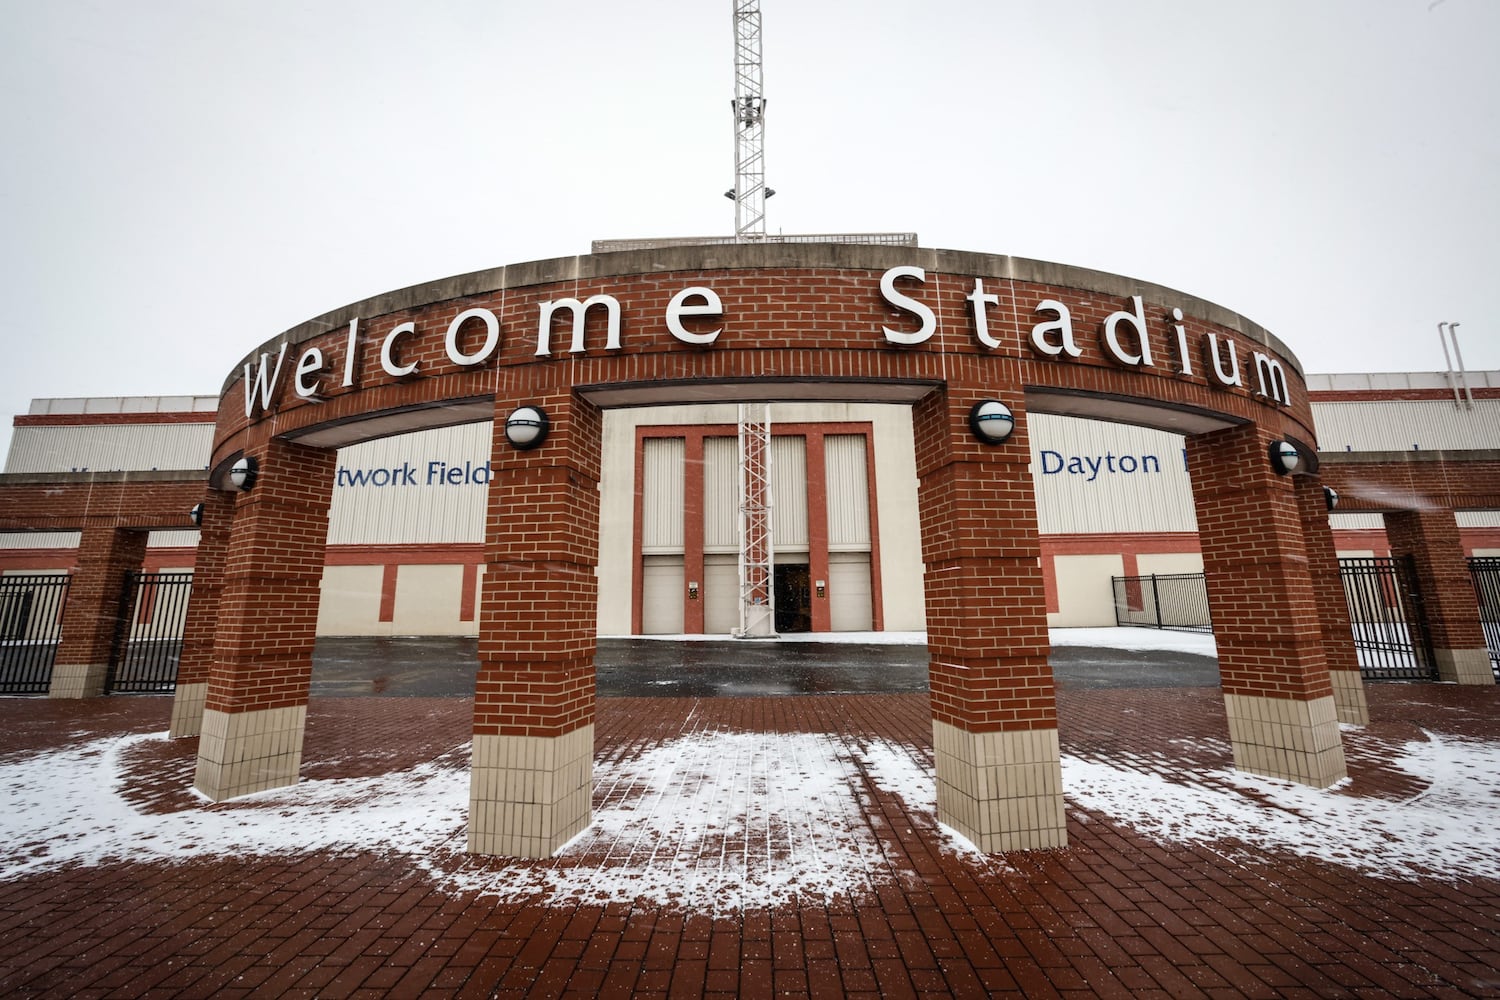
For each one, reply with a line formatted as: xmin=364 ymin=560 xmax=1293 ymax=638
xmin=0 ymin=716 xmax=1500 ymax=913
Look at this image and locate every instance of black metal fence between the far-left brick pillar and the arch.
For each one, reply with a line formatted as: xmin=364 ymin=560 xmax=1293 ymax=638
xmin=105 ymin=573 xmax=192 ymax=693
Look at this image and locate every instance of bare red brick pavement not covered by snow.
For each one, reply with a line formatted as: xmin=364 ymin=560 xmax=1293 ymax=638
xmin=0 ymin=685 xmax=1500 ymax=997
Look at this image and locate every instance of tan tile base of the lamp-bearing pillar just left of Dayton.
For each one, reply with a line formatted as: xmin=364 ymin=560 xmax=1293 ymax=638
xmin=933 ymin=720 xmax=1068 ymax=855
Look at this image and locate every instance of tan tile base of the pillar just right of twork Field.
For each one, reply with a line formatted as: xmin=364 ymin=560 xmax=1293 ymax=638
xmin=468 ymin=723 xmax=594 ymax=858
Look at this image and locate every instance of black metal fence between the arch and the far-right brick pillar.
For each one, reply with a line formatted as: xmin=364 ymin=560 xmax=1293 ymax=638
xmin=1338 ymin=556 xmax=1437 ymax=681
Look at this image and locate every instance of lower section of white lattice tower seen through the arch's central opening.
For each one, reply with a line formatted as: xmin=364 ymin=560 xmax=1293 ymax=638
xmin=735 ymin=403 xmax=776 ymax=639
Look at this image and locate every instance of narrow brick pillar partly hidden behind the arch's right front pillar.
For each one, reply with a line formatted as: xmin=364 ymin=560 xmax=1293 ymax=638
xmin=1295 ymin=475 xmax=1370 ymax=726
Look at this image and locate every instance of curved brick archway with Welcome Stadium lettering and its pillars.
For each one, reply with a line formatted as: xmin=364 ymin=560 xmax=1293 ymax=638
xmin=174 ymin=244 xmax=1364 ymax=856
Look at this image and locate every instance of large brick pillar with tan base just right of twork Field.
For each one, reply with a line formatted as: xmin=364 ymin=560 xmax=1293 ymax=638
xmin=468 ymin=385 xmax=603 ymax=858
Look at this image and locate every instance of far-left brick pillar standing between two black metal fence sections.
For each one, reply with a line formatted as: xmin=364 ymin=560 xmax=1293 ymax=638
xmin=47 ymin=519 xmax=147 ymax=699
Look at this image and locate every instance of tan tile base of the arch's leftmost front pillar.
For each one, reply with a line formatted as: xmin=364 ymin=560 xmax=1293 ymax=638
xmin=194 ymin=705 xmax=308 ymax=802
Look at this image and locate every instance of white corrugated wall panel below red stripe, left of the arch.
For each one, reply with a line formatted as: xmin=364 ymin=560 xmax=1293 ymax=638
xmin=5 ymin=424 xmax=213 ymax=472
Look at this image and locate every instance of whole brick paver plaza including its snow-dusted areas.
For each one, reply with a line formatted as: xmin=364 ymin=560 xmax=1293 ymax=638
xmin=0 ymin=685 xmax=1500 ymax=997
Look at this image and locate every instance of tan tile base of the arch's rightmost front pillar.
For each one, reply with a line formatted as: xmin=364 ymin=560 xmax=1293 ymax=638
xmin=1224 ymin=694 xmax=1349 ymax=789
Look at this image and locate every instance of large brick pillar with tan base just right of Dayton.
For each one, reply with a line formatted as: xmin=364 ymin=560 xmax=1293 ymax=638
xmin=1187 ymin=424 xmax=1347 ymax=789
